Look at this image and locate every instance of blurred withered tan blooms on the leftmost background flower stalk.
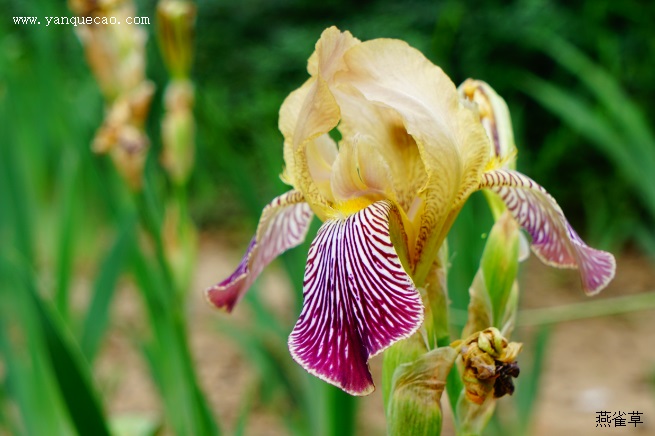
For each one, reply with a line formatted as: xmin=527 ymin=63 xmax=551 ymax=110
xmin=68 ymin=0 xmax=154 ymax=190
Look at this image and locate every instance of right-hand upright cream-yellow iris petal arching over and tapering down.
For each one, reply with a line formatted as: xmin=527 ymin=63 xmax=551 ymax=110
xmin=337 ymin=39 xmax=490 ymax=279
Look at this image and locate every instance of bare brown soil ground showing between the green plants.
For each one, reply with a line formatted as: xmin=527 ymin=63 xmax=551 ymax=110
xmin=96 ymin=237 xmax=655 ymax=436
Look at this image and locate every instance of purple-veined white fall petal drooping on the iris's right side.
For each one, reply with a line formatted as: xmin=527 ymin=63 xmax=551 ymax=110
xmin=480 ymin=170 xmax=616 ymax=295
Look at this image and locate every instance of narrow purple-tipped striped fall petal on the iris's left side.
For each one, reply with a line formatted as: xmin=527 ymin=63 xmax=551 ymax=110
xmin=205 ymin=191 xmax=313 ymax=312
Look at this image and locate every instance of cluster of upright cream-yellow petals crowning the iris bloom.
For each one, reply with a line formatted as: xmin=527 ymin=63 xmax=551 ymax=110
xmin=280 ymin=28 xmax=492 ymax=280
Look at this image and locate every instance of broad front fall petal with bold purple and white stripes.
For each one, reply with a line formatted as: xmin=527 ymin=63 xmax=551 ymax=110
xmin=289 ymin=201 xmax=423 ymax=395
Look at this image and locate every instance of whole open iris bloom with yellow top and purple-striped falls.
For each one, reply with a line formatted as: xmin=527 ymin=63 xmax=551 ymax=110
xmin=206 ymin=27 xmax=615 ymax=395
